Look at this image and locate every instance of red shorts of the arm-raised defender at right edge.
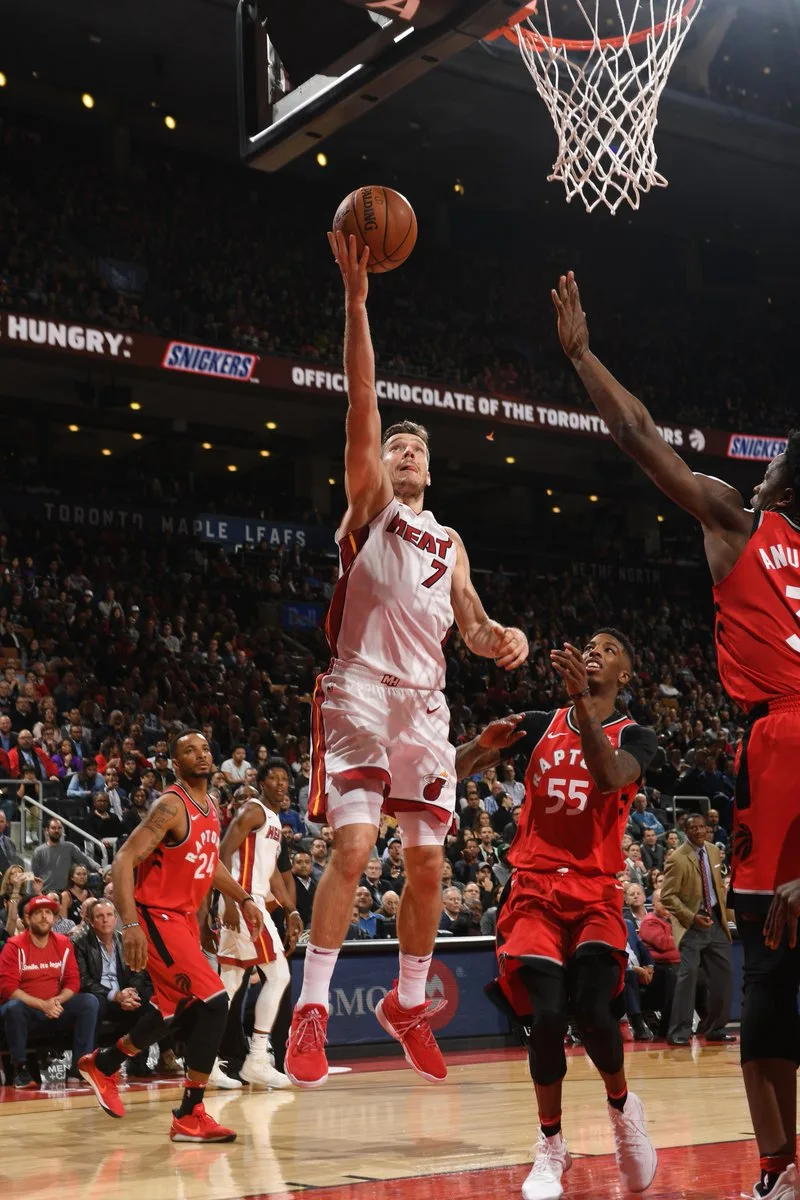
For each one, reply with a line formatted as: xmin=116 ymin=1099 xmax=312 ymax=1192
xmin=732 ymin=696 xmax=800 ymax=905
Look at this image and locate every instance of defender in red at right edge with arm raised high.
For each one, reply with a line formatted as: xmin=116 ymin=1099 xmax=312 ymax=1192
xmin=553 ymin=272 xmax=800 ymax=1200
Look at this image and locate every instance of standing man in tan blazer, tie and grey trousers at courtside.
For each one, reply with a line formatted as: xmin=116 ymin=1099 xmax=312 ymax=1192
xmin=661 ymin=812 xmax=734 ymax=1046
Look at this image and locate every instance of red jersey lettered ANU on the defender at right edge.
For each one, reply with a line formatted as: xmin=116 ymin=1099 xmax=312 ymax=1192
xmin=714 ymin=512 xmax=800 ymax=709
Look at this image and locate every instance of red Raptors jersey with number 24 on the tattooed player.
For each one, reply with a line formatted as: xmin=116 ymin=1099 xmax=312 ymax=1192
xmin=133 ymin=784 xmax=219 ymax=913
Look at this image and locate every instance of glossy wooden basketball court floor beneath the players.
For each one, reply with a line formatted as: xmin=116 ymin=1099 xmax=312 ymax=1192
xmin=0 ymin=1043 xmax=782 ymax=1200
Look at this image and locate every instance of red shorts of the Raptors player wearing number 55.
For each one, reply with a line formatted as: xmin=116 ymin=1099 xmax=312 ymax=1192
xmin=497 ymin=870 xmax=627 ymax=976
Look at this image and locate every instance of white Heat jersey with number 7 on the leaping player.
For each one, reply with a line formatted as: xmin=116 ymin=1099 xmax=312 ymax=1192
xmin=325 ymin=499 xmax=457 ymax=691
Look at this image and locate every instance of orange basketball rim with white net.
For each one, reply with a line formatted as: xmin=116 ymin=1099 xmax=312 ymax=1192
xmin=489 ymin=0 xmax=703 ymax=212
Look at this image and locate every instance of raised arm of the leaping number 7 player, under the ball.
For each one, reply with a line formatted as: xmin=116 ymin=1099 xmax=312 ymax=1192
xmin=327 ymin=232 xmax=392 ymax=533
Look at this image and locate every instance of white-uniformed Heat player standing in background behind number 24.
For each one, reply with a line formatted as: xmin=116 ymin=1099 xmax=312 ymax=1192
xmin=211 ymin=758 xmax=302 ymax=1088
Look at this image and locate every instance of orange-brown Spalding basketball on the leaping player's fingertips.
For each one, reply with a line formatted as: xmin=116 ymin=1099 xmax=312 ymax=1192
xmin=333 ymin=186 xmax=416 ymax=275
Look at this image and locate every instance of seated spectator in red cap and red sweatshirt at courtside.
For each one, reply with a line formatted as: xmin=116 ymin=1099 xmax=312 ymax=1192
xmin=0 ymin=895 xmax=100 ymax=1087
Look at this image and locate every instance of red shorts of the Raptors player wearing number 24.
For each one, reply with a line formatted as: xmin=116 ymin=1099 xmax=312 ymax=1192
xmin=137 ymin=905 xmax=225 ymax=1018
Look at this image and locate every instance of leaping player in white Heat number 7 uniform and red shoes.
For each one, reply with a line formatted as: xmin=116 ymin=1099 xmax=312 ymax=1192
xmin=285 ymin=233 xmax=528 ymax=1087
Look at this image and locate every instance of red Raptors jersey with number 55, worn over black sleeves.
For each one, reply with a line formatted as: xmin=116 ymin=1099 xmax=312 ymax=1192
xmin=509 ymin=708 xmax=656 ymax=875
